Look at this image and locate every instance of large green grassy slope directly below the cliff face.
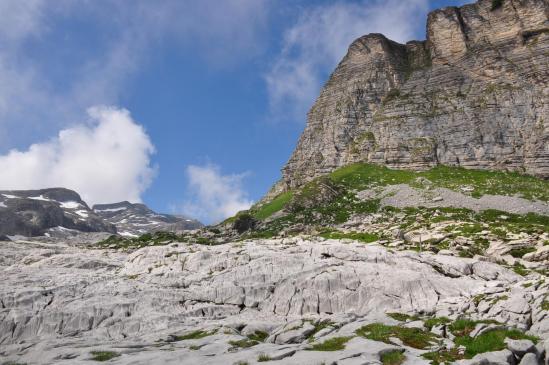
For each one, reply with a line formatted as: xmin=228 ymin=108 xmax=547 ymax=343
xmin=226 ymin=163 xmax=549 ymax=240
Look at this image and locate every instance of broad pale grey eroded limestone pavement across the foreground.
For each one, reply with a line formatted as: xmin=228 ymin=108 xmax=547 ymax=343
xmin=0 ymin=237 xmax=549 ymax=364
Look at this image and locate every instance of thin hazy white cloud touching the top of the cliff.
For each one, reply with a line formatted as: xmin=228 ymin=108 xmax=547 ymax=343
xmin=265 ymin=0 xmax=429 ymax=122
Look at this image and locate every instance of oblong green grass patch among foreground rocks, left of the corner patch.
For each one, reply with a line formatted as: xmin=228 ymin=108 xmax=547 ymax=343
xmin=356 ymin=323 xmax=438 ymax=349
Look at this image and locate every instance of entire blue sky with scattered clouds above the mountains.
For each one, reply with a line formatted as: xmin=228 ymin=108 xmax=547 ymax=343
xmin=0 ymin=0 xmax=463 ymax=222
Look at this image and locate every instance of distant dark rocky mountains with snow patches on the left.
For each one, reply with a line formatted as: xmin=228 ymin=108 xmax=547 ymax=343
xmin=0 ymin=188 xmax=202 ymax=239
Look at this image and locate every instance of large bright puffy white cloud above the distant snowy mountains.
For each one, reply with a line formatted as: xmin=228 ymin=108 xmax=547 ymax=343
xmin=0 ymin=106 xmax=154 ymax=204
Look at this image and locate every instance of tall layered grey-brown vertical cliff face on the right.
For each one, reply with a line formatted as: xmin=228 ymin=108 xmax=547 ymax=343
xmin=278 ymin=0 xmax=549 ymax=189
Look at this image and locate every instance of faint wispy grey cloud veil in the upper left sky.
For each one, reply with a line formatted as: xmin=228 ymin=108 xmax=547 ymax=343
xmin=0 ymin=0 xmax=268 ymax=151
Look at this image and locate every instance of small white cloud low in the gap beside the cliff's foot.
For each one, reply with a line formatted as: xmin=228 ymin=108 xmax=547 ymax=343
xmin=183 ymin=164 xmax=253 ymax=223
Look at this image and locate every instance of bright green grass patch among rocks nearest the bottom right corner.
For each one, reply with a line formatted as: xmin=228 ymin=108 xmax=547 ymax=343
xmin=454 ymin=329 xmax=539 ymax=359
